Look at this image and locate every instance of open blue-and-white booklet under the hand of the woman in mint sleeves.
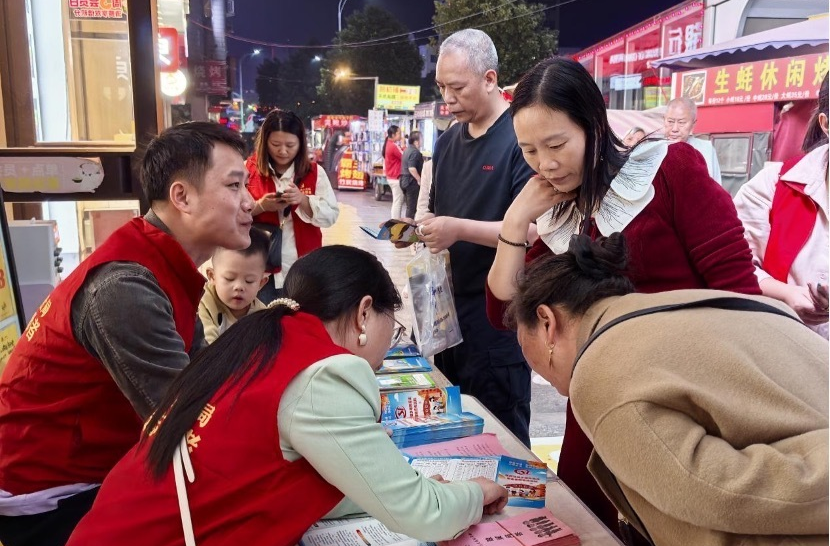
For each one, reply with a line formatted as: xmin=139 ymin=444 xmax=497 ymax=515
xmin=409 ymin=456 xmax=548 ymax=508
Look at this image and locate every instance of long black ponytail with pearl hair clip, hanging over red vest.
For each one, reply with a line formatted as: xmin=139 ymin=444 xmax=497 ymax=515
xmin=141 ymin=245 xmax=401 ymax=479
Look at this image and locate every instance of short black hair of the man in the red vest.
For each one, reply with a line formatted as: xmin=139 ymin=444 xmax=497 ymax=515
xmin=141 ymin=121 xmax=245 ymax=203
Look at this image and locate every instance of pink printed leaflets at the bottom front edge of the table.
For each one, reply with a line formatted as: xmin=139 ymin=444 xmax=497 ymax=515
xmin=438 ymin=508 xmax=580 ymax=546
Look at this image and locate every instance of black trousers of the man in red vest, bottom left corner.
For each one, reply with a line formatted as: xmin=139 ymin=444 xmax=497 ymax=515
xmin=0 ymin=487 xmax=99 ymax=546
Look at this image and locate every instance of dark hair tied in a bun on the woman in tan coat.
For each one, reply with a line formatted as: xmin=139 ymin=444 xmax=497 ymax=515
xmin=506 ymin=233 xmax=634 ymax=328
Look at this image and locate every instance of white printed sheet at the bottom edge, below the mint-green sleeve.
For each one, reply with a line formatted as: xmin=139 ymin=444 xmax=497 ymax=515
xmin=300 ymin=518 xmax=431 ymax=546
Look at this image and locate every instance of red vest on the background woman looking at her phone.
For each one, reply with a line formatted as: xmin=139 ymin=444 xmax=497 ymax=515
xmin=245 ymin=154 xmax=323 ymax=273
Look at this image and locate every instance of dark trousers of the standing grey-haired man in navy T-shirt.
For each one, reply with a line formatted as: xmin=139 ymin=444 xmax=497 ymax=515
xmin=435 ymin=294 xmax=530 ymax=447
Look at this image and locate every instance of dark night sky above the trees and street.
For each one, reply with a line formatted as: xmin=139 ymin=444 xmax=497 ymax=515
xmin=228 ymin=0 xmax=680 ymax=62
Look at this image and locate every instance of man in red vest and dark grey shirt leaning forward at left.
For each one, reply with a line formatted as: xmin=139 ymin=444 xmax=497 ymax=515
xmin=0 ymin=122 xmax=254 ymax=546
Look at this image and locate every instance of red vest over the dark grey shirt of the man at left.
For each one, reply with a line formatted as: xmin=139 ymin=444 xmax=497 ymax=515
xmin=0 ymin=218 xmax=204 ymax=495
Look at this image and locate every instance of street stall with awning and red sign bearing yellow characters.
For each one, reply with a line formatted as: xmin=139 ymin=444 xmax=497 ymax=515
xmin=652 ymin=17 xmax=829 ymax=195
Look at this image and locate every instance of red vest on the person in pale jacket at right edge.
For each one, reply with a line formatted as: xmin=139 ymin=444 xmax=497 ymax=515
xmin=763 ymin=155 xmax=818 ymax=284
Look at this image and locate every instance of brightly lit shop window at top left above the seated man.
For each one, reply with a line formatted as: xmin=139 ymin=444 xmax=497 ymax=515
xmin=26 ymin=0 xmax=135 ymax=145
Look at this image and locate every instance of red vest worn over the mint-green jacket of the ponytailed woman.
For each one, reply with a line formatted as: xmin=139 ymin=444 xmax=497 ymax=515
xmin=67 ymin=313 xmax=346 ymax=546
